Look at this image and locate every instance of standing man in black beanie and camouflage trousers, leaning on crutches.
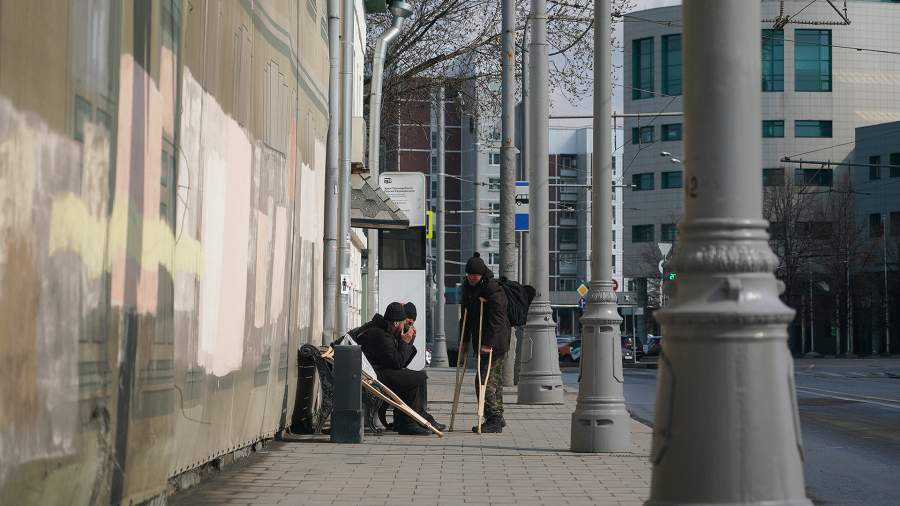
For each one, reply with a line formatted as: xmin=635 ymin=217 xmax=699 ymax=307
xmin=460 ymin=251 xmax=510 ymax=433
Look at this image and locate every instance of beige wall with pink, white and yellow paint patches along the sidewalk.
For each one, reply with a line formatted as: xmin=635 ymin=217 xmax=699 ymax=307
xmin=0 ymin=0 xmax=328 ymax=504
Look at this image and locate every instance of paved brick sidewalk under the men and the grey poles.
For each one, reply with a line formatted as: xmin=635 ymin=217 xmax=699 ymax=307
xmin=171 ymin=368 xmax=651 ymax=505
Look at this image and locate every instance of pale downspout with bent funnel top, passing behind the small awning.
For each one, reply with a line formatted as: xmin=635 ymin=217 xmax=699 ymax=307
xmin=363 ymin=0 xmax=412 ymax=320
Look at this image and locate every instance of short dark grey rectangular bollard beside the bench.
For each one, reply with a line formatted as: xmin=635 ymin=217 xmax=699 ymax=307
xmin=331 ymin=346 xmax=363 ymax=443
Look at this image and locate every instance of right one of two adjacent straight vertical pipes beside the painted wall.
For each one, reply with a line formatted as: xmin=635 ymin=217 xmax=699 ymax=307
xmin=335 ymin=0 xmax=354 ymax=336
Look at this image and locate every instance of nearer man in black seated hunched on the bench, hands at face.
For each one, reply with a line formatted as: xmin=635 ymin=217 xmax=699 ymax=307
xmin=356 ymin=302 xmax=441 ymax=435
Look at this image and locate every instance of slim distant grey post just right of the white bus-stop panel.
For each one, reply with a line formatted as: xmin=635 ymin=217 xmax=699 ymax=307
xmin=431 ymin=86 xmax=450 ymax=367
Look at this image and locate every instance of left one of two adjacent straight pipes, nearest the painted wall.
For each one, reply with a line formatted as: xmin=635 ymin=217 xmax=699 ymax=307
xmin=322 ymin=0 xmax=341 ymax=344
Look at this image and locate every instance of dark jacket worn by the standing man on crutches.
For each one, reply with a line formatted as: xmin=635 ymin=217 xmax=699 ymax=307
xmin=459 ymin=271 xmax=510 ymax=358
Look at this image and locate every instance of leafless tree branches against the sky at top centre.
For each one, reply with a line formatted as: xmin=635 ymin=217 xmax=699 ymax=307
xmin=365 ymin=0 xmax=635 ymax=136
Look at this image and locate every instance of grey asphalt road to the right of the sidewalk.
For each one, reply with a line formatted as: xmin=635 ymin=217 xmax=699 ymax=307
xmin=563 ymin=359 xmax=900 ymax=506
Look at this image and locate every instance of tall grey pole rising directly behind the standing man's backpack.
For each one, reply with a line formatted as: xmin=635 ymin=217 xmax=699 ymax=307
xmin=500 ymin=0 xmax=519 ymax=386
